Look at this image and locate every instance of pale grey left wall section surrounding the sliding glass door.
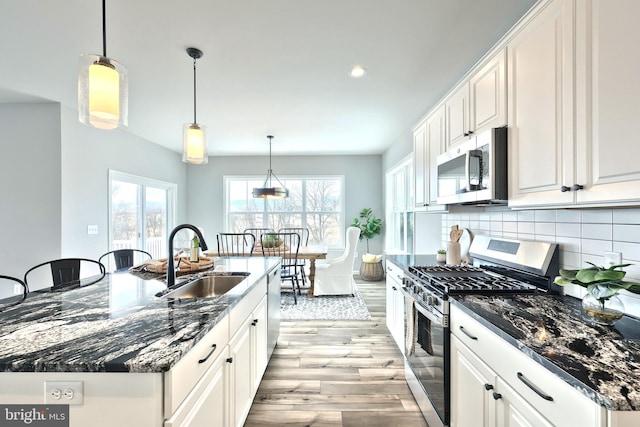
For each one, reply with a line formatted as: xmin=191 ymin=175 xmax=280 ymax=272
xmin=62 ymin=107 xmax=187 ymax=259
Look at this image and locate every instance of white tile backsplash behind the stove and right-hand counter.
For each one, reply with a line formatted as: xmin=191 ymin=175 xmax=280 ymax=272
xmin=442 ymin=207 xmax=640 ymax=317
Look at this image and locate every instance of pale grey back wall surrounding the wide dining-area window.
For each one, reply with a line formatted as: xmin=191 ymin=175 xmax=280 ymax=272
xmin=187 ymin=155 xmax=384 ymax=265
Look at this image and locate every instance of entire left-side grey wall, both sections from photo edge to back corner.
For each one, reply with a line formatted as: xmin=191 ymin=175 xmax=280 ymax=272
xmin=0 ymin=103 xmax=187 ymax=284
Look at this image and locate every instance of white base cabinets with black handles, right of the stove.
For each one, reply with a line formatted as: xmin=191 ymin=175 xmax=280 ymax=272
xmin=451 ymin=304 xmax=607 ymax=427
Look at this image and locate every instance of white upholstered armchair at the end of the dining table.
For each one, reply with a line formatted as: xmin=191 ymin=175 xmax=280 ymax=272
xmin=313 ymin=227 xmax=360 ymax=295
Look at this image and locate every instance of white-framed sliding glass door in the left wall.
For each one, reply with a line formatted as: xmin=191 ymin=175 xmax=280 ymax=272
xmin=109 ymin=170 xmax=177 ymax=258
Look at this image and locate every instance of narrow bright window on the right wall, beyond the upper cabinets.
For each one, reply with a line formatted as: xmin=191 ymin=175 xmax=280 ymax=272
xmin=386 ymin=156 xmax=414 ymax=253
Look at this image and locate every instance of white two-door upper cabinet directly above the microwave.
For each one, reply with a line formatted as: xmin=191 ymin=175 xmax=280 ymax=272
xmin=445 ymin=49 xmax=507 ymax=149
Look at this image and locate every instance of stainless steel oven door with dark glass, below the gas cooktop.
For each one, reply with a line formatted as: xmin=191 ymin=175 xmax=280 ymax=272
xmin=404 ymin=292 xmax=450 ymax=426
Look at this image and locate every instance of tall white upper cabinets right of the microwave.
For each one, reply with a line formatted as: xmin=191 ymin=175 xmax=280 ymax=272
xmin=508 ymin=0 xmax=640 ymax=207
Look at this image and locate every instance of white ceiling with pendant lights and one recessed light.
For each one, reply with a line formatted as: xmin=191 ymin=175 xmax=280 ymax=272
xmin=0 ymin=0 xmax=535 ymax=155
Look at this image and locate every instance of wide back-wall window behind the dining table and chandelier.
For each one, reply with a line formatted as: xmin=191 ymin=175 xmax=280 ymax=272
xmin=225 ymin=176 xmax=344 ymax=248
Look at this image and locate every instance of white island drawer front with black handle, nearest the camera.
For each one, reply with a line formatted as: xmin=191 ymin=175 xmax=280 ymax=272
xmin=164 ymin=316 xmax=229 ymax=418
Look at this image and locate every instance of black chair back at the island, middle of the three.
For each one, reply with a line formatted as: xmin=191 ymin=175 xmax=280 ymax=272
xmin=24 ymin=258 xmax=106 ymax=290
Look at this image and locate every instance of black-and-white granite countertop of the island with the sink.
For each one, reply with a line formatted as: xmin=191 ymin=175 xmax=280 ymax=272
xmin=0 ymin=257 xmax=279 ymax=372
